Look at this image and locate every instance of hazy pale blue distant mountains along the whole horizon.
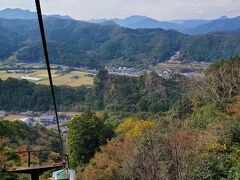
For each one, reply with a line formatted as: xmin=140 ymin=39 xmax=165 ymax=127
xmin=0 ymin=8 xmax=240 ymax=35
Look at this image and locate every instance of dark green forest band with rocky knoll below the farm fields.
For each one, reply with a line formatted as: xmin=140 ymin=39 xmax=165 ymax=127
xmin=0 ymin=70 xmax=187 ymax=113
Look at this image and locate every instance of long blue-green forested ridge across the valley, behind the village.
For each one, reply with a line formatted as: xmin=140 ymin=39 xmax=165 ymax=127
xmin=0 ymin=18 xmax=240 ymax=68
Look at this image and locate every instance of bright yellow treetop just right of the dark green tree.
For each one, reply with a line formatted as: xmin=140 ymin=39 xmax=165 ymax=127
xmin=115 ymin=118 xmax=155 ymax=138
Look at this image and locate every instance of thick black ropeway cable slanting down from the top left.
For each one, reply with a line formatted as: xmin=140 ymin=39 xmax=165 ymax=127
xmin=35 ymin=0 xmax=64 ymax=160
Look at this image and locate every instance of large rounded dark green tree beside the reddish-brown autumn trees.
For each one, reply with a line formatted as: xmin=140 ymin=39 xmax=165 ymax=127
xmin=68 ymin=111 xmax=113 ymax=167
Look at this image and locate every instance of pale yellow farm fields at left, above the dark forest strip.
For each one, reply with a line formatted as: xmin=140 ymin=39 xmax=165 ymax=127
xmin=0 ymin=70 xmax=93 ymax=87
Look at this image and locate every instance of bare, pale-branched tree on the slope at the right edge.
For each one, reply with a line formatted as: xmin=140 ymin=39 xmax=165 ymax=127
xmin=193 ymin=57 xmax=240 ymax=104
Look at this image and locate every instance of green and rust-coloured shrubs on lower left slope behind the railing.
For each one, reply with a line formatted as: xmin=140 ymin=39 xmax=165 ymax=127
xmin=0 ymin=120 xmax=60 ymax=180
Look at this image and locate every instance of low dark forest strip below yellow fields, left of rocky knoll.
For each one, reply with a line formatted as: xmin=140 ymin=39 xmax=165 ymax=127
xmin=0 ymin=78 xmax=88 ymax=112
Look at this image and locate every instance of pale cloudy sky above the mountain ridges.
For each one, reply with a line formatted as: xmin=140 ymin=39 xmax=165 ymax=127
xmin=0 ymin=0 xmax=240 ymax=20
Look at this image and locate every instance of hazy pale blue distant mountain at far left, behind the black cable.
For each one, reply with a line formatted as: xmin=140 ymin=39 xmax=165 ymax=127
xmin=0 ymin=8 xmax=72 ymax=20
